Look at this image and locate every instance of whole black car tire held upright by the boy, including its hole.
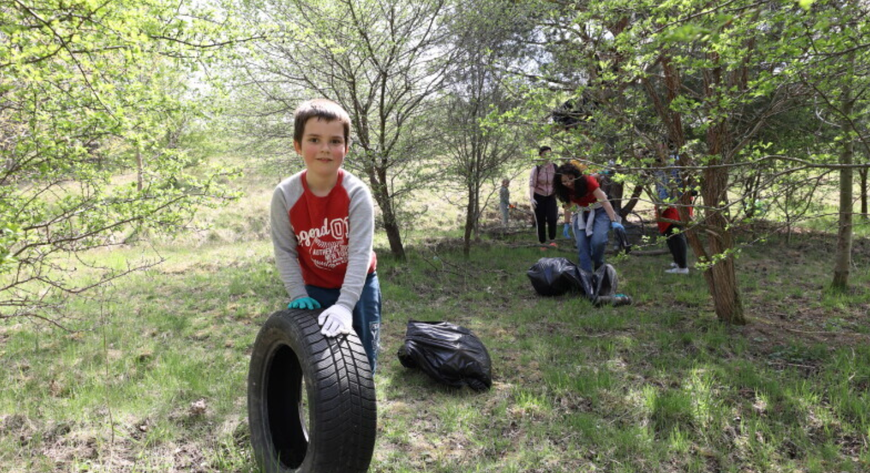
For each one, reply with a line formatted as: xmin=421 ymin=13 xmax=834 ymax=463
xmin=248 ymin=309 xmax=377 ymax=473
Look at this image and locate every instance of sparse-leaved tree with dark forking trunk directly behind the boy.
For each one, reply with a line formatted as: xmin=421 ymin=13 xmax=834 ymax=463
xmin=228 ymin=0 xmax=455 ymax=259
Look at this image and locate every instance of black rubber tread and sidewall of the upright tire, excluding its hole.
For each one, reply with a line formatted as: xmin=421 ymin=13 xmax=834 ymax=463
xmin=248 ymin=310 xmax=377 ymax=473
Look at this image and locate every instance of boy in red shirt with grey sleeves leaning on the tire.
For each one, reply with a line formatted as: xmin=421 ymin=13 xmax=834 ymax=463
xmin=271 ymin=99 xmax=381 ymax=373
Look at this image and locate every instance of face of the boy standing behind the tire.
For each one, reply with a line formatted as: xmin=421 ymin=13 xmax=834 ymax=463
xmin=293 ymin=118 xmax=349 ymax=176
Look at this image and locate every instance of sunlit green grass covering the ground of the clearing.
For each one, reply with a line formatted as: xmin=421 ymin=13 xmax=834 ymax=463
xmin=0 ymin=160 xmax=870 ymax=473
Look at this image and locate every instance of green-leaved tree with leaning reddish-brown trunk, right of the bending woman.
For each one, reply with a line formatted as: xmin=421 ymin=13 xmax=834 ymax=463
xmin=508 ymin=1 xmax=868 ymax=324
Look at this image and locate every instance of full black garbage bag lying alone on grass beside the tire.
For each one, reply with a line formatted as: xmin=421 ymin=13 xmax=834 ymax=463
xmin=398 ymin=320 xmax=492 ymax=391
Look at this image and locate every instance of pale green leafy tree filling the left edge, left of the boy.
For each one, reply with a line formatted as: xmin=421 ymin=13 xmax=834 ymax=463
xmin=0 ymin=0 xmax=238 ymax=323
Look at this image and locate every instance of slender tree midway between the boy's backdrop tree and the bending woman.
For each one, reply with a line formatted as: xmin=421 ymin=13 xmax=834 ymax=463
xmin=432 ymin=0 xmax=528 ymax=258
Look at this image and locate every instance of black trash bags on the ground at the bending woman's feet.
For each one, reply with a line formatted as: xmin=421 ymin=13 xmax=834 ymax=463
xmin=526 ymin=258 xmax=631 ymax=306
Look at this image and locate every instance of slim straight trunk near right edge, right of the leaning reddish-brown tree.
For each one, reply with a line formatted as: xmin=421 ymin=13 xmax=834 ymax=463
xmin=831 ymin=59 xmax=855 ymax=292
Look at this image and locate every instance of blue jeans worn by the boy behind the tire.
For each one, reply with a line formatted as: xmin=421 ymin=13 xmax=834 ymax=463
xmin=305 ymin=273 xmax=381 ymax=374
